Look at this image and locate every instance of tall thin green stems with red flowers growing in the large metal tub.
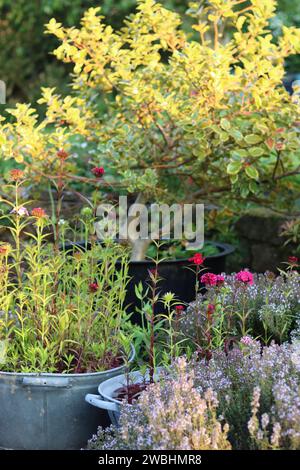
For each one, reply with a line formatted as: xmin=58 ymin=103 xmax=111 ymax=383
xmin=0 ymin=174 xmax=130 ymax=373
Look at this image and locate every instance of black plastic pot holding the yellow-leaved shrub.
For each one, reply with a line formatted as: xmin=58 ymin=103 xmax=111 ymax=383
xmin=116 ymin=242 xmax=235 ymax=324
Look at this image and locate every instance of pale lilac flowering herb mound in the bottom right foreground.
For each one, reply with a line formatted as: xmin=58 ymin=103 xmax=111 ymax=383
xmin=89 ymin=337 xmax=300 ymax=450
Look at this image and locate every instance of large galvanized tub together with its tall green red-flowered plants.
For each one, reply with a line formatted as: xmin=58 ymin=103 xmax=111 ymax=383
xmin=0 ymin=169 xmax=134 ymax=449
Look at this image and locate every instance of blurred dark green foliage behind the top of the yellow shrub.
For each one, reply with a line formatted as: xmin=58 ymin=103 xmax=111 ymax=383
xmin=0 ymin=0 xmax=300 ymax=105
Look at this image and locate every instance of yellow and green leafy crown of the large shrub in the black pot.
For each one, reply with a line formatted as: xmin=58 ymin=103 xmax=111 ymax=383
xmin=0 ymin=0 xmax=300 ymax=260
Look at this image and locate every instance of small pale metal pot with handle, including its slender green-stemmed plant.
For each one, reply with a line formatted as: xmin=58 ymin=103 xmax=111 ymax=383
xmin=85 ymin=268 xmax=190 ymax=425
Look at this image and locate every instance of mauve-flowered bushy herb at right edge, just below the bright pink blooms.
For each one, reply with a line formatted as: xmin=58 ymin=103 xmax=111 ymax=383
xmin=180 ymin=270 xmax=300 ymax=350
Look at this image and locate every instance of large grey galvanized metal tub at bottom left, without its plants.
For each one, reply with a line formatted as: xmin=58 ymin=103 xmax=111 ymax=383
xmin=0 ymin=348 xmax=135 ymax=450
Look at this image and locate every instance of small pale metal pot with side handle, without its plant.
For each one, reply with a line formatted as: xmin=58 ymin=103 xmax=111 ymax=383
xmin=85 ymin=367 xmax=163 ymax=426
